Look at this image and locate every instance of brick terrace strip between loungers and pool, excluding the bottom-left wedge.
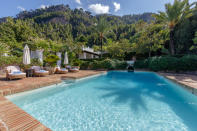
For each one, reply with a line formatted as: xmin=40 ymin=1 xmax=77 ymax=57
xmin=0 ymin=70 xmax=104 ymax=96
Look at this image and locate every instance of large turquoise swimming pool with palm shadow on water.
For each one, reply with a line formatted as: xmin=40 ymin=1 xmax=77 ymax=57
xmin=8 ymin=71 xmax=197 ymax=131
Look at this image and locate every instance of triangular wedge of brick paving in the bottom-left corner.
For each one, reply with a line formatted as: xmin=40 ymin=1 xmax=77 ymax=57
xmin=0 ymin=97 xmax=50 ymax=131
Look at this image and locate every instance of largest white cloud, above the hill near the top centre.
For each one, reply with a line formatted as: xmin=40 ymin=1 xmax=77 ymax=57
xmin=89 ymin=4 xmax=109 ymax=14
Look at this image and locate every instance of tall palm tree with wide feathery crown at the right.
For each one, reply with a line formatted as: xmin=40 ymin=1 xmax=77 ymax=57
xmin=153 ymin=0 xmax=194 ymax=55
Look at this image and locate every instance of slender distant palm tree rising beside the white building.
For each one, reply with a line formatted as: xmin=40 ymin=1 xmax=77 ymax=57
xmin=96 ymin=17 xmax=108 ymax=57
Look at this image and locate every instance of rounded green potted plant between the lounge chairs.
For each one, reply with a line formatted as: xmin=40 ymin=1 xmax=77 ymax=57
xmin=44 ymin=55 xmax=59 ymax=75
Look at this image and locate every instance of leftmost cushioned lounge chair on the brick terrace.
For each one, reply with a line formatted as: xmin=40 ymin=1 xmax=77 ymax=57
xmin=6 ymin=66 xmax=26 ymax=80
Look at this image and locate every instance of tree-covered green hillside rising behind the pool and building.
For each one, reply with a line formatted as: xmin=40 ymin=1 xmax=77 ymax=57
xmin=0 ymin=0 xmax=197 ymax=59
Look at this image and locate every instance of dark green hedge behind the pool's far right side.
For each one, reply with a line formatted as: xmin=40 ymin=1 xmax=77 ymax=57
xmin=134 ymin=55 xmax=197 ymax=71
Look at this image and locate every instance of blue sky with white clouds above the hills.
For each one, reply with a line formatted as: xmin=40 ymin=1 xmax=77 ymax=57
xmin=0 ymin=0 xmax=195 ymax=17
